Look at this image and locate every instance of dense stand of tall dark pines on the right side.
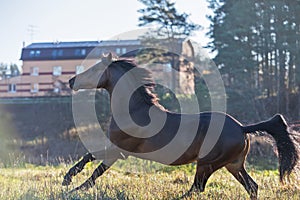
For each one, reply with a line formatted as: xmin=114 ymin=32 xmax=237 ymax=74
xmin=208 ymin=0 xmax=300 ymax=119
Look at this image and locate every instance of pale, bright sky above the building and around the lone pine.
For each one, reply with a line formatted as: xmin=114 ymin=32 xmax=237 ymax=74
xmin=0 ymin=0 xmax=211 ymax=65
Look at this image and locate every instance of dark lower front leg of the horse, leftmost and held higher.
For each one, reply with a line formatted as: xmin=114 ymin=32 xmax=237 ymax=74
xmin=62 ymin=153 xmax=95 ymax=186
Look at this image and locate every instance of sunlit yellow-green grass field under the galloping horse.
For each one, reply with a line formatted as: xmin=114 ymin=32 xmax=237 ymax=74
xmin=0 ymin=158 xmax=300 ymax=200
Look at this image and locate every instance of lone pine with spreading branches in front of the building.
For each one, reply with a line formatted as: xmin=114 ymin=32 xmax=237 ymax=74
xmin=138 ymin=0 xmax=200 ymax=91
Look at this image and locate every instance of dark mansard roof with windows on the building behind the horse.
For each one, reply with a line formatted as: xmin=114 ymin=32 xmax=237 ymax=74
xmin=21 ymin=40 xmax=141 ymax=61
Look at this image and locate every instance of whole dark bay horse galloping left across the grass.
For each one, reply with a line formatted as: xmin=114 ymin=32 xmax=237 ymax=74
xmin=63 ymin=54 xmax=299 ymax=199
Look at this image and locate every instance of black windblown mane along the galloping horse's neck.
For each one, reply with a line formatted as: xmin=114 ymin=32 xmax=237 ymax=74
xmin=112 ymin=59 xmax=164 ymax=109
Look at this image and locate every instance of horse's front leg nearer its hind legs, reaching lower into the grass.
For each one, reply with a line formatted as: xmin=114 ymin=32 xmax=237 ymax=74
xmin=70 ymin=158 xmax=117 ymax=192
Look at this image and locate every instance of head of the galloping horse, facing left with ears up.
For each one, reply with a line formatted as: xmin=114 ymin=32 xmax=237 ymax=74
xmin=69 ymin=53 xmax=113 ymax=91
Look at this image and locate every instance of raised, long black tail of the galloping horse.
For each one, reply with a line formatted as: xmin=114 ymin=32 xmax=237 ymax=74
xmin=242 ymin=114 xmax=299 ymax=182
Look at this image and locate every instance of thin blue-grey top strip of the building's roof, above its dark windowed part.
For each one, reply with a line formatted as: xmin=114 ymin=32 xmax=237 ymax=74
xmin=24 ymin=40 xmax=141 ymax=49
